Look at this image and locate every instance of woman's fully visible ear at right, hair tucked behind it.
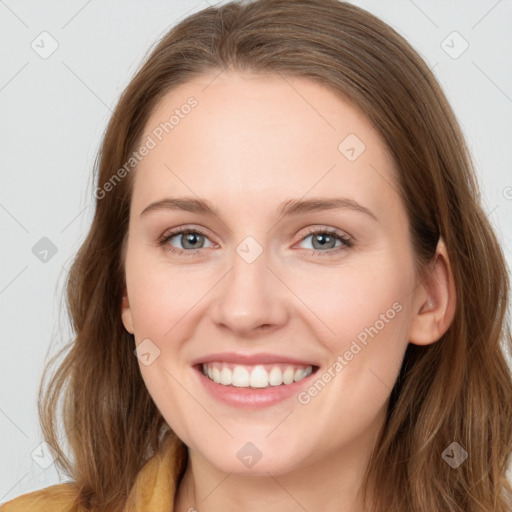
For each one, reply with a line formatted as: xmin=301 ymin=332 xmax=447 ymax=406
xmin=409 ymin=238 xmax=456 ymax=345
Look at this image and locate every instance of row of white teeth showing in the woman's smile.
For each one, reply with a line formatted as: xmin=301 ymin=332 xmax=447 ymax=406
xmin=203 ymin=363 xmax=313 ymax=388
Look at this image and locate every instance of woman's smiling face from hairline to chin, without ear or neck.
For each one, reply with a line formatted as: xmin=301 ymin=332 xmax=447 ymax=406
xmin=123 ymin=72 xmax=424 ymax=475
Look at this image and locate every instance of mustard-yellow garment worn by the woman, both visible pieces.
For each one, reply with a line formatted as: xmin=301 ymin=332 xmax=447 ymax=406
xmin=0 ymin=433 xmax=186 ymax=512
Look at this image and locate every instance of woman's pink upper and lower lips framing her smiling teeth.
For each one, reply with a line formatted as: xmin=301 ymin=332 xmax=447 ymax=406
xmin=193 ymin=352 xmax=319 ymax=409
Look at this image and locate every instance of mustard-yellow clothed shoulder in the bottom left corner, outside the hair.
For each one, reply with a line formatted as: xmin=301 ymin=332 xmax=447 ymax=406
xmin=0 ymin=483 xmax=81 ymax=512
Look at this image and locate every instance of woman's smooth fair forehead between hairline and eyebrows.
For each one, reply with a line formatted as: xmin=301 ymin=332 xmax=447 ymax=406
xmin=133 ymin=72 xmax=404 ymax=222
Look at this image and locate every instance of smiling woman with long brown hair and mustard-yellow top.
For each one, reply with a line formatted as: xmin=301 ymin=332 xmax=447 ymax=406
xmin=1 ymin=0 xmax=512 ymax=512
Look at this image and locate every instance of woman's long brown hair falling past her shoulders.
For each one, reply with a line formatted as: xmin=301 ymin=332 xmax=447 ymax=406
xmin=39 ymin=0 xmax=512 ymax=512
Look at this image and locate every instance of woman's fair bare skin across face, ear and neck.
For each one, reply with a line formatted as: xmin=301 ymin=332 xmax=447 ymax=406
xmin=122 ymin=71 xmax=455 ymax=512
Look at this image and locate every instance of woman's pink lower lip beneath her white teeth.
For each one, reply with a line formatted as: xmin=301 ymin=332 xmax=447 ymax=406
xmin=195 ymin=367 xmax=316 ymax=409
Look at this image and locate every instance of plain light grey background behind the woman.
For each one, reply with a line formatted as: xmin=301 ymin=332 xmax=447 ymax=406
xmin=0 ymin=0 xmax=512 ymax=503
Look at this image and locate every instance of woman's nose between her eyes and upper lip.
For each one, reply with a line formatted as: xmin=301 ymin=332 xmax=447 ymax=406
xmin=211 ymin=246 xmax=290 ymax=338
